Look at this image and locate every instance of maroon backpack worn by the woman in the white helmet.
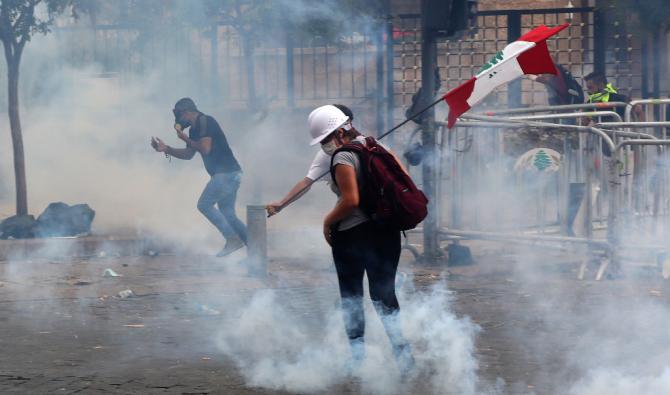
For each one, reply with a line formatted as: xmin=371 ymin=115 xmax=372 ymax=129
xmin=330 ymin=137 xmax=428 ymax=230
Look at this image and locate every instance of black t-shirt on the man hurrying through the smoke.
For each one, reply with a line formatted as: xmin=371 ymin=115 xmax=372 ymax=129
xmin=188 ymin=114 xmax=242 ymax=176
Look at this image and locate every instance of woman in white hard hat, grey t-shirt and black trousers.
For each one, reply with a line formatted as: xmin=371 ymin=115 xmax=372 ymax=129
xmin=308 ymin=105 xmax=414 ymax=373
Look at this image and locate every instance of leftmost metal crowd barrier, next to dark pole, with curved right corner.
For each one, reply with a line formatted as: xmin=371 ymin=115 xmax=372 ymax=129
xmin=438 ymin=116 xmax=611 ymax=241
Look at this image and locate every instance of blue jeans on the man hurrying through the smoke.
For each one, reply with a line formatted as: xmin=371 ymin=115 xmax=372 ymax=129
xmin=198 ymin=172 xmax=247 ymax=243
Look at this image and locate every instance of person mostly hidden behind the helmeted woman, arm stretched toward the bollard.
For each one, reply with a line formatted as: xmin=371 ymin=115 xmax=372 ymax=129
xmin=265 ymin=104 xmax=354 ymax=217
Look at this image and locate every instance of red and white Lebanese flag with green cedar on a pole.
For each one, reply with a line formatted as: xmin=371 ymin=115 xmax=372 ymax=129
xmin=444 ymin=23 xmax=570 ymax=128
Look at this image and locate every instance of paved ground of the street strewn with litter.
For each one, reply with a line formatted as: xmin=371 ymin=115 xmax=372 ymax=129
xmin=0 ymin=240 xmax=670 ymax=394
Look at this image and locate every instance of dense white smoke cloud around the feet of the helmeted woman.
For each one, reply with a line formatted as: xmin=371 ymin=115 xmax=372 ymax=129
xmin=217 ymin=282 xmax=480 ymax=394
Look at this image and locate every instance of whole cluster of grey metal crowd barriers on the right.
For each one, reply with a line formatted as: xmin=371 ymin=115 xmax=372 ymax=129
xmin=430 ymin=100 xmax=670 ymax=279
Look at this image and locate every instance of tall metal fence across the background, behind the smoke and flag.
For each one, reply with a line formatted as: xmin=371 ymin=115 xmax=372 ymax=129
xmin=0 ymin=7 xmax=641 ymax=130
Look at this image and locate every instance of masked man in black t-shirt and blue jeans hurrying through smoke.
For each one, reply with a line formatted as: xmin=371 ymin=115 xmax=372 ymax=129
xmin=151 ymin=97 xmax=247 ymax=257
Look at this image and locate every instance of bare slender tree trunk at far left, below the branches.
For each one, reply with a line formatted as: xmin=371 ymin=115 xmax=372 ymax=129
xmin=7 ymin=58 xmax=28 ymax=215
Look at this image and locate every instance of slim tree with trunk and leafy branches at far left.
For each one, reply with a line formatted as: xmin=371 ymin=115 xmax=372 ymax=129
xmin=0 ymin=0 xmax=73 ymax=215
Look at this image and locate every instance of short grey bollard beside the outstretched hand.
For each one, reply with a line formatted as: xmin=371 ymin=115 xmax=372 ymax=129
xmin=247 ymin=205 xmax=268 ymax=277
